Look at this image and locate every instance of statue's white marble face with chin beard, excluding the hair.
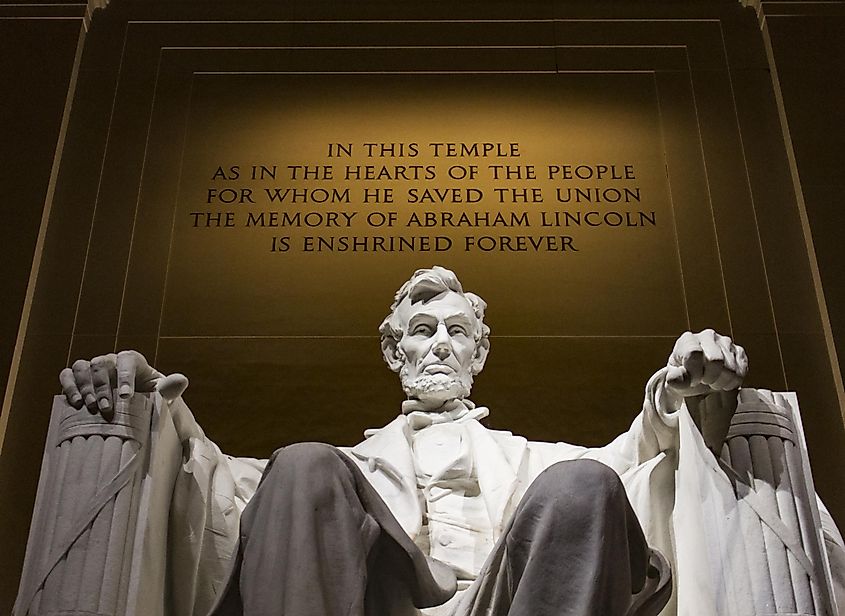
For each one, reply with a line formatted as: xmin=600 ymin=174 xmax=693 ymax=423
xmin=398 ymin=291 xmax=479 ymax=408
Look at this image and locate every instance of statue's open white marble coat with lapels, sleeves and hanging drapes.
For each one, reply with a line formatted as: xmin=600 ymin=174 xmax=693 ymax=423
xmin=168 ymin=370 xmax=845 ymax=616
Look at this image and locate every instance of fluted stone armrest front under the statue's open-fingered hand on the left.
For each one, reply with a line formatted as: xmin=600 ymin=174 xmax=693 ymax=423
xmin=14 ymin=394 xmax=181 ymax=616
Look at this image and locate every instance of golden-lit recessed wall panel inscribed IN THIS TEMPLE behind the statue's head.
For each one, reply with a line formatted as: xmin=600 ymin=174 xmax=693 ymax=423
xmin=161 ymin=72 xmax=684 ymax=336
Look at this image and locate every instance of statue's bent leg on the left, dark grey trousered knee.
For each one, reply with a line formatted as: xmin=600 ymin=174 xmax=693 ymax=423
xmin=213 ymin=443 xmax=448 ymax=616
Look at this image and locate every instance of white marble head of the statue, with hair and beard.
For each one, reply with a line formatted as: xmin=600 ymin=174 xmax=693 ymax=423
xmin=379 ymin=266 xmax=490 ymax=410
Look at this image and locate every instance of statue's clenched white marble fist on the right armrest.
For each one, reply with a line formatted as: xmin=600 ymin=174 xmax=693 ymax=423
xmin=666 ymin=329 xmax=748 ymax=398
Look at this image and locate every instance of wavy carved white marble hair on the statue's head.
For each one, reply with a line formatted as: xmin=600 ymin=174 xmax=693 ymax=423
xmin=379 ymin=265 xmax=490 ymax=370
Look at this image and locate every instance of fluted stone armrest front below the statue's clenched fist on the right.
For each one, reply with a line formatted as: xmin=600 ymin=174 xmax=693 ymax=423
xmin=720 ymin=389 xmax=836 ymax=616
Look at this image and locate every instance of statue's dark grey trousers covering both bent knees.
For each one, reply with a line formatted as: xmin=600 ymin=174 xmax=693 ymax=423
xmin=206 ymin=443 xmax=668 ymax=616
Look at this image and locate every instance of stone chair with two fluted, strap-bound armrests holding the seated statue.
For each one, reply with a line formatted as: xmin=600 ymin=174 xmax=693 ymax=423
xmin=9 ymin=389 xmax=836 ymax=616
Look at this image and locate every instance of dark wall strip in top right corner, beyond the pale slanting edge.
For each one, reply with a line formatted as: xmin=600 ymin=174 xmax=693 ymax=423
xmin=762 ymin=2 xmax=845 ymax=422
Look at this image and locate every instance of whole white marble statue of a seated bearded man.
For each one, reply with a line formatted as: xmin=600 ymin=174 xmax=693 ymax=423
xmin=60 ymin=267 xmax=845 ymax=616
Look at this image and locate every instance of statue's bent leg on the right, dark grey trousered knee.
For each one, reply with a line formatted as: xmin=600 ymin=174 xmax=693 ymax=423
xmin=457 ymin=460 xmax=650 ymax=616
